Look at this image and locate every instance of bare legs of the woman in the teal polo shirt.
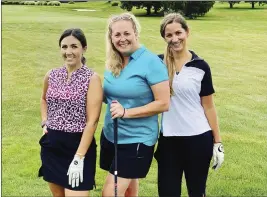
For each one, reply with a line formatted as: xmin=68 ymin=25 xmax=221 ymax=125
xmin=102 ymin=173 xmax=132 ymax=197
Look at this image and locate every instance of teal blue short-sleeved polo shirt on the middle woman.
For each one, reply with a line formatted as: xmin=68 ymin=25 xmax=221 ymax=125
xmin=103 ymin=46 xmax=169 ymax=146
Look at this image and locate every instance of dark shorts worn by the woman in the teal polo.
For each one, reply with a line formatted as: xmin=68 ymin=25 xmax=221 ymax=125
xmin=100 ymin=131 xmax=154 ymax=179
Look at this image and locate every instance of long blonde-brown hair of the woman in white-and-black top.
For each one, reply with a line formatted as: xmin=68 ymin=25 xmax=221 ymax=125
xmin=160 ymin=13 xmax=188 ymax=95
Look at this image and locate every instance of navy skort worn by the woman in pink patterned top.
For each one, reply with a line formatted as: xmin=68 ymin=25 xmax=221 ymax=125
xmin=38 ymin=128 xmax=96 ymax=191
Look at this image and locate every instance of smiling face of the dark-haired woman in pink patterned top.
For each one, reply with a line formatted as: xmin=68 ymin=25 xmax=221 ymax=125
xmin=60 ymin=36 xmax=86 ymax=66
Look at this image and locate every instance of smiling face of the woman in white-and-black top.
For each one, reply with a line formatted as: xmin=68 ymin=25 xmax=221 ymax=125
xmin=164 ymin=22 xmax=189 ymax=52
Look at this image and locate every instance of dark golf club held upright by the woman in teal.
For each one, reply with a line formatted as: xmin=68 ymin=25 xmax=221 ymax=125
xmin=113 ymin=118 xmax=118 ymax=197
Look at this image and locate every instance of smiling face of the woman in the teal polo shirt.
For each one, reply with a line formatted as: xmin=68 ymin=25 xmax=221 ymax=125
xmin=111 ymin=20 xmax=139 ymax=56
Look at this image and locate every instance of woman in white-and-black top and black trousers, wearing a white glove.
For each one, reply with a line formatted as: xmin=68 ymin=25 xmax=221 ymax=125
xmin=155 ymin=13 xmax=224 ymax=197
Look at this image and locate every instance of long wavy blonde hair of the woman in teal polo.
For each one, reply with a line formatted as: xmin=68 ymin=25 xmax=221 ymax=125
xmin=106 ymin=12 xmax=141 ymax=77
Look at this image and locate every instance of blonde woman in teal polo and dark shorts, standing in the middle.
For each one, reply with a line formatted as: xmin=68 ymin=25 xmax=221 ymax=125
xmin=100 ymin=13 xmax=170 ymax=196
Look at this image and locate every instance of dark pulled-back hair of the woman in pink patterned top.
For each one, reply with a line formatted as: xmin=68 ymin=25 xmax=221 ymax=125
xmin=58 ymin=28 xmax=87 ymax=64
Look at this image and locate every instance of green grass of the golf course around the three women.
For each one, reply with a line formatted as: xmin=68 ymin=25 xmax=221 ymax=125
xmin=2 ymin=2 xmax=267 ymax=196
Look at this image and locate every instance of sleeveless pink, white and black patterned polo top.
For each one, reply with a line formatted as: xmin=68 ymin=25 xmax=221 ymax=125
xmin=46 ymin=65 xmax=94 ymax=132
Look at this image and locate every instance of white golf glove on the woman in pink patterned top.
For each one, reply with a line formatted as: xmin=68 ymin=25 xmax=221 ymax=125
xmin=67 ymin=155 xmax=84 ymax=188
